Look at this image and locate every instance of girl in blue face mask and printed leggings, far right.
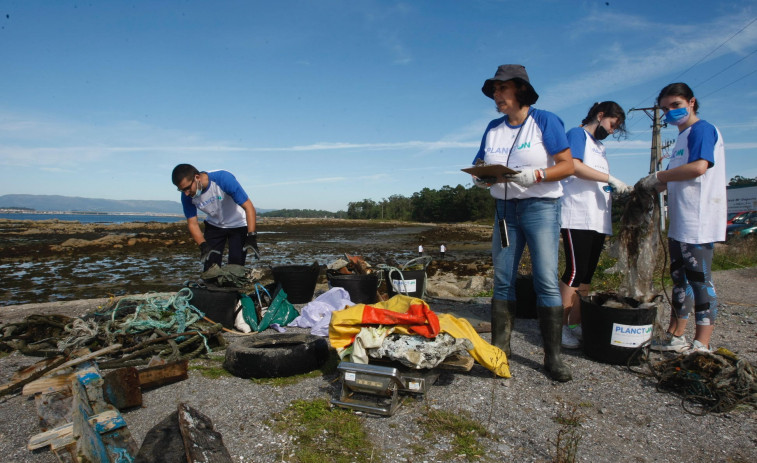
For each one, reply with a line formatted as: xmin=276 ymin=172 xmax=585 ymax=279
xmin=641 ymin=82 xmax=728 ymax=352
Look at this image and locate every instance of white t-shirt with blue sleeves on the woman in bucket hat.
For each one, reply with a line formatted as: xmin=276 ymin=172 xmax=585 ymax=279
xmin=473 ymin=108 xmax=569 ymax=199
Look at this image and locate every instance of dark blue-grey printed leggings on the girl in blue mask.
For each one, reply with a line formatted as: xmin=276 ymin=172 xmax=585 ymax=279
xmin=668 ymin=238 xmax=718 ymax=326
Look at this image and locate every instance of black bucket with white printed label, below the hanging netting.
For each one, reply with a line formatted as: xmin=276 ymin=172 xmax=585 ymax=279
xmin=581 ymin=294 xmax=657 ymax=365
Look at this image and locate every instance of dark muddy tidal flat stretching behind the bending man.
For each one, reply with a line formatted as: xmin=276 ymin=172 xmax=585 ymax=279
xmin=0 ymin=219 xmax=491 ymax=306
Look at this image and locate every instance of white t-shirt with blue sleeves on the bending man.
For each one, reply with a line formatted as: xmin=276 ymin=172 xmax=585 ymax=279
xmin=181 ymin=170 xmax=249 ymax=228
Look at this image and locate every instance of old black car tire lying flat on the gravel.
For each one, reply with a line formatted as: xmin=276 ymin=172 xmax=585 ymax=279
xmin=223 ymin=333 xmax=329 ymax=378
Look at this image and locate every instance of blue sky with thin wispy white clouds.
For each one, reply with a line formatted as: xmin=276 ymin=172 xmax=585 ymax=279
xmin=0 ymin=0 xmax=757 ymax=212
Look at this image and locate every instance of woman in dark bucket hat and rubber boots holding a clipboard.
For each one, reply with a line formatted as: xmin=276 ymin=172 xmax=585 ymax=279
xmin=473 ymin=64 xmax=573 ymax=381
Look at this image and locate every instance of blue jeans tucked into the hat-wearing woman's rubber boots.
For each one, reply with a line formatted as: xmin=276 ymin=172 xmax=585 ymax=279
xmin=492 ymin=198 xmax=562 ymax=307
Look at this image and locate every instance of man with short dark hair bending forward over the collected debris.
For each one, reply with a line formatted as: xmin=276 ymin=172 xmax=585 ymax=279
xmin=171 ymin=164 xmax=260 ymax=270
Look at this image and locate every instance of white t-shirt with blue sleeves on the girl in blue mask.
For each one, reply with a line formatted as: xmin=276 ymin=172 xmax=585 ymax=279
xmin=667 ymin=120 xmax=728 ymax=244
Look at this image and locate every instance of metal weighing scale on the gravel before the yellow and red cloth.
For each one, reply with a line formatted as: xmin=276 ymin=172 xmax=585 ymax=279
xmin=331 ymin=362 xmax=439 ymax=416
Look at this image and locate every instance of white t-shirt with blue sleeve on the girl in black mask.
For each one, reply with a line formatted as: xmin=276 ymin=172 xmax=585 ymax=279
xmin=560 ymin=127 xmax=612 ymax=235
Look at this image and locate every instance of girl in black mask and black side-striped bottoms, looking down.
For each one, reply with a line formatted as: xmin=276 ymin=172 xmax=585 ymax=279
xmin=560 ymin=101 xmax=631 ymax=349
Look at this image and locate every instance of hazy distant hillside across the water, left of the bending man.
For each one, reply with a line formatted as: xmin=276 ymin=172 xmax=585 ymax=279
xmin=0 ymin=195 xmax=182 ymax=214
